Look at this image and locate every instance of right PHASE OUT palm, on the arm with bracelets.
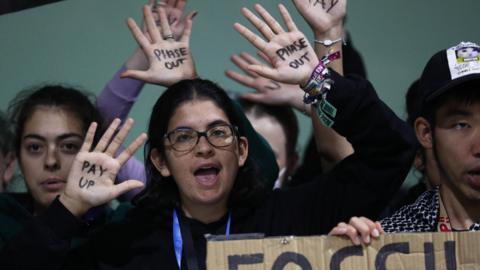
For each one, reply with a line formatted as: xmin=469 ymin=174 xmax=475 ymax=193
xmin=234 ymin=4 xmax=318 ymax=84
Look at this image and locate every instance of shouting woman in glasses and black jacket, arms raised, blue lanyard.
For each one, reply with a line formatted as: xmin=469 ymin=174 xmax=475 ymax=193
xmin=0 ymin=5 xmax=414 ymax=270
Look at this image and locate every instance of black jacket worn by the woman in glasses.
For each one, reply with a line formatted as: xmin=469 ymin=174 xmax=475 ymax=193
xmin=0 ymin=72 xmax=415 ymax=269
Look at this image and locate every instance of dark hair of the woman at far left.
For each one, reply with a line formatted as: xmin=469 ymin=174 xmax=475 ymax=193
xmin=8 ymin=84 xmax=105 ymax=156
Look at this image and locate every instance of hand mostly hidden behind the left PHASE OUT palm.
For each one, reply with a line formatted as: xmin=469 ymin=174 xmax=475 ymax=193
xmin=125 ymin=0 xmax=197 ymax=70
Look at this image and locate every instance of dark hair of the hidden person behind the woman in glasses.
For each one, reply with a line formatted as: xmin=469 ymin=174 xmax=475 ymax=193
xmin=239 ymin=99 xmax=299 ymax=160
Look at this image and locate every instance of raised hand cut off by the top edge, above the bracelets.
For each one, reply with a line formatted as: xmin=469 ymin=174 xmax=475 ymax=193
xmin=292 ymin=0 xmax=347 ymax=36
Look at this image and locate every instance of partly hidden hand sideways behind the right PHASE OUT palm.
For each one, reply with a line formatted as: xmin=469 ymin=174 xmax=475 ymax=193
xmin=225 ymin=52 xmax=305 ymax=114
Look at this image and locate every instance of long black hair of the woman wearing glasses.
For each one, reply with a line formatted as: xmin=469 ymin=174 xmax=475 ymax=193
xmin=133 ymin=79 xmax=263 ymax=211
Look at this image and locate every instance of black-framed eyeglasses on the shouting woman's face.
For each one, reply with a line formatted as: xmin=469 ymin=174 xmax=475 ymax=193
xmin=164 ymin=124 xmax=237 ymax=152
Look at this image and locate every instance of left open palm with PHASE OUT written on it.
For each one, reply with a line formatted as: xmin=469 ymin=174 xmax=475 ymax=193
xmin=122 ymin=6 xmax=196 ymax=86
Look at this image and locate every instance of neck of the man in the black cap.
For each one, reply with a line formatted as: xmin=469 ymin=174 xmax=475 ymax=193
xmin=440 ymin=184 xmax=480 ymax=230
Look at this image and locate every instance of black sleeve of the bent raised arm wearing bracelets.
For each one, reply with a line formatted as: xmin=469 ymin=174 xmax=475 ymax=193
xmin=264 ymin=71 xmax=415 ymax=235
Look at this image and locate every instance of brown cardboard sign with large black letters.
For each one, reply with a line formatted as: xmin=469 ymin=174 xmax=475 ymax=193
xmin=207 ymin=232 xmax=480 ymax=270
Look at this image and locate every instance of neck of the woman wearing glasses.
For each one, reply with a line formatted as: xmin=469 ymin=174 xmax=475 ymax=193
xmin=182 ymin=199 xmax=227 ymax=224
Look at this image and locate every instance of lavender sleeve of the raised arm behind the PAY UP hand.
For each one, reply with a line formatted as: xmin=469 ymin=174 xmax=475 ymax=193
xmin=97 ymin=66 xmax=147 ymax=201
